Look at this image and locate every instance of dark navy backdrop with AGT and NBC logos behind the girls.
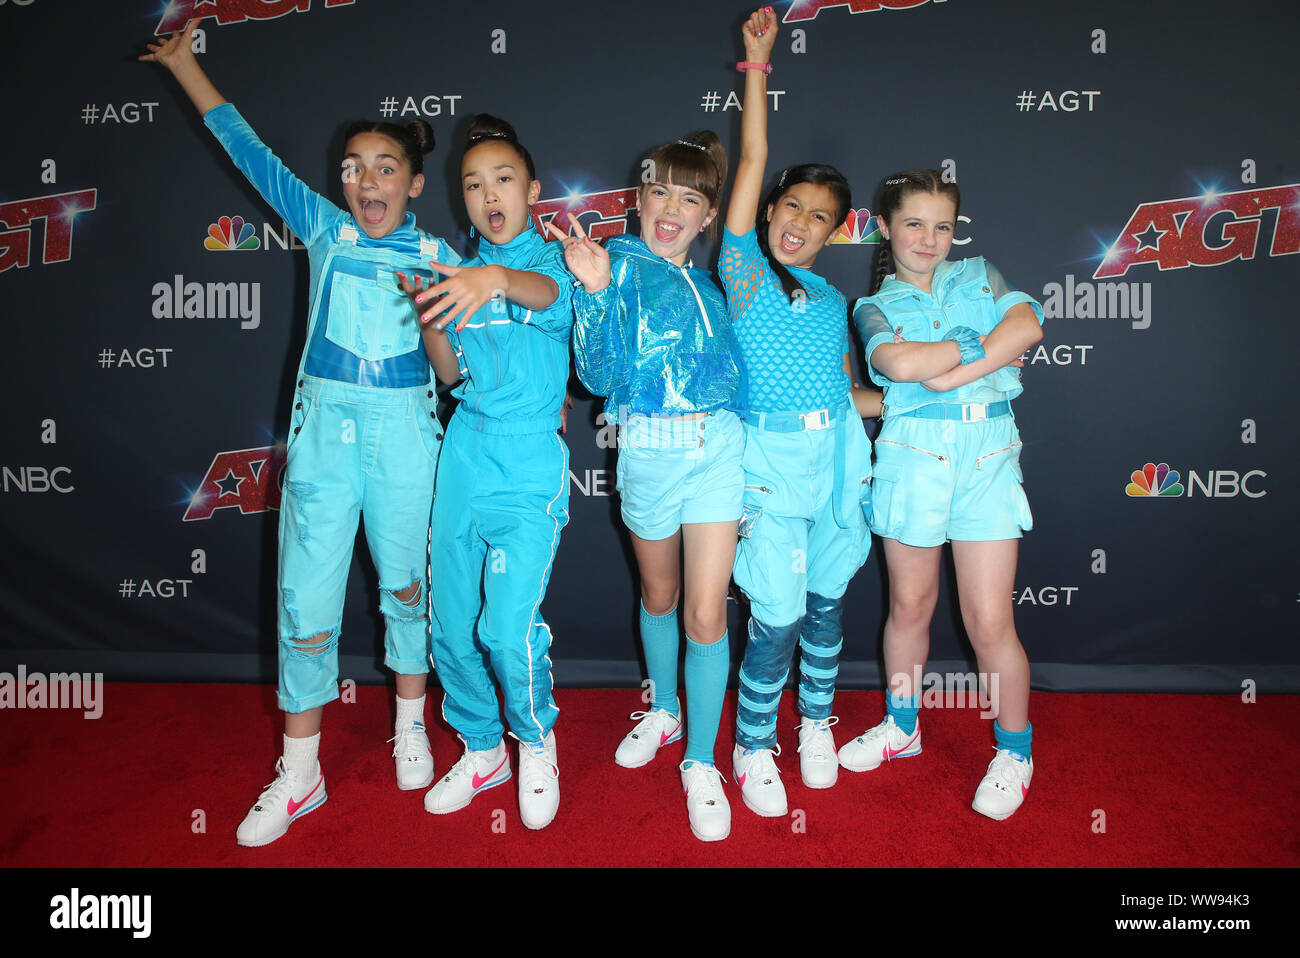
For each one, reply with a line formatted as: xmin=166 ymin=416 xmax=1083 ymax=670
xmin=0 ymin=0 xmax=1300 ymax=695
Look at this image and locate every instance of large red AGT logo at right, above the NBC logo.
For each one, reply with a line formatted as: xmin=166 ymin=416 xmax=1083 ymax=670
xmin=1092 ymin=183 xmax=1300 ymax=279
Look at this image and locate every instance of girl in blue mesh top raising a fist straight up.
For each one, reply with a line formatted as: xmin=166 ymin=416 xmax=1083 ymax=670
xmin=718 ymin=6 xmax=880 ymax=816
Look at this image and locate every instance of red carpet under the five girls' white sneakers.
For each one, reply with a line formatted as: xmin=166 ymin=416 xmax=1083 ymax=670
xmin=0 ymin=684 xmax=1300 ymax=868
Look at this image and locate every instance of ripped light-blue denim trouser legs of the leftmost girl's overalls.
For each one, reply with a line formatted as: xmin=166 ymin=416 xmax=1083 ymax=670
xmin=277 ymin=376 xmax=442 ymax=712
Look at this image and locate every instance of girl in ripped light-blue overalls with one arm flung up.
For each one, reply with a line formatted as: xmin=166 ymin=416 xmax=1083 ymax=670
xmin=140 ymin=21 xmax=455 ymax=845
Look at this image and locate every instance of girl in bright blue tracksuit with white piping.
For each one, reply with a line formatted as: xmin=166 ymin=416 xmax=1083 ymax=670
xmin=416 ymin=116 xmax=573 ymax=828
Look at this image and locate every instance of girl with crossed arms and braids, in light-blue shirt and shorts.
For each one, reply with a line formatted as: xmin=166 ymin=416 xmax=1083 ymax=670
xmin=840 ymin=170 xmax=1043 ymax=820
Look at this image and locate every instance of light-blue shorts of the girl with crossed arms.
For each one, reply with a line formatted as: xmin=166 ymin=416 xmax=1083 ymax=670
xmin=871 ymin=415 xmax=1034 ymax=547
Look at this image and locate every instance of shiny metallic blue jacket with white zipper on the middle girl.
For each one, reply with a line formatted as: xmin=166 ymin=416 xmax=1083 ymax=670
xmin=573 ymin=237 xmax=742 ymax=422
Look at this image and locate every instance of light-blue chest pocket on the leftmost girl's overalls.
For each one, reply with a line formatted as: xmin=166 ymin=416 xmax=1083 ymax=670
xmin=325 ymin=257 xmax=420 ymax=363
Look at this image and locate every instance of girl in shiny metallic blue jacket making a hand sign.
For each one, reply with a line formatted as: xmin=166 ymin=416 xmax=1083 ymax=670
xmin=551 ymin=131 xmax=745 ymax=841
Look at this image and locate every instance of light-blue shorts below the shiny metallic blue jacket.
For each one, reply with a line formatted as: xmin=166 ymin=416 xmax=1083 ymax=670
xmin=618 ymin=409 xmax=745 ymax=539
